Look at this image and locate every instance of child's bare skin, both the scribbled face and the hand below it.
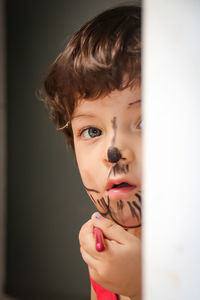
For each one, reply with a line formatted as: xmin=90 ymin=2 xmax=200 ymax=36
xmin=72 ymin=87 xmax=142 ymax=300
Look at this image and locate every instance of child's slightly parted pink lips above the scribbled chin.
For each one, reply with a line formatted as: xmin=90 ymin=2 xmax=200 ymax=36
xmin=106 ymin=180 xmax=136 ymax=198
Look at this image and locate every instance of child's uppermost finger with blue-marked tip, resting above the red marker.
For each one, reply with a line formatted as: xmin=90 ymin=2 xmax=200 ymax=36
xmin=91 ymin=212 xmax=134 ymax=244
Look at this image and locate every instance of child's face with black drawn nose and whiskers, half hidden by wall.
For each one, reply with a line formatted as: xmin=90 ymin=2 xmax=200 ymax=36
xmin=72 ymin=87 xmax=142 ymax=228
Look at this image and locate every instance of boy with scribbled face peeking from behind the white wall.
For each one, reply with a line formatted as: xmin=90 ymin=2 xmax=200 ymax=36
xmin=45 ymin=6 xmax=142 ymax=300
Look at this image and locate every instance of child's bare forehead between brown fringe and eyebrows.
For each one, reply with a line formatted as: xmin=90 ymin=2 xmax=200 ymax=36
xmin=72 ymin=87 xmax=141 ymax=118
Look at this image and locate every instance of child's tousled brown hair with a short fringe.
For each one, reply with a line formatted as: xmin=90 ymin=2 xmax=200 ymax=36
xmin=43 ymin=5 xmax=141 ymax=147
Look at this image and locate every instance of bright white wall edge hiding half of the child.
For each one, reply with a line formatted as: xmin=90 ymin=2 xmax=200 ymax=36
xmin=144 ymin=0 xmax=200 ymax=300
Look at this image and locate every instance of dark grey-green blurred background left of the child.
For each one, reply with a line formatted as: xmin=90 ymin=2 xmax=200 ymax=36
xmin=0 ymin=0 xmax=141 ymax=300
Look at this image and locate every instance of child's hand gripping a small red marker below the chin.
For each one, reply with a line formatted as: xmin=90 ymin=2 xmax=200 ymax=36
xmin=79 ymin=213 xmax=141 ymax=300
